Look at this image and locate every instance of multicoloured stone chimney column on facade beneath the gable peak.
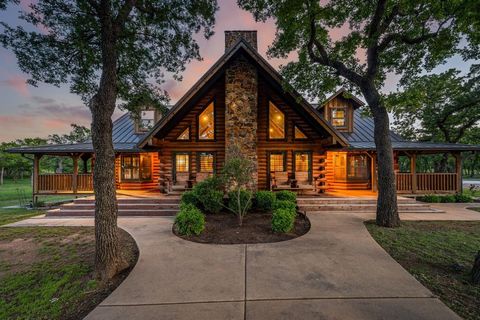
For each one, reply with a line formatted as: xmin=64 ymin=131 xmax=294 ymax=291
xmin=225 ymin=56 xmax=258 ymax=186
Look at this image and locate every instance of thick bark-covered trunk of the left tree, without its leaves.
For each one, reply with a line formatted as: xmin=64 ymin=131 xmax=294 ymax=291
xmin=90 ymin=13 xmax=128 ymax=281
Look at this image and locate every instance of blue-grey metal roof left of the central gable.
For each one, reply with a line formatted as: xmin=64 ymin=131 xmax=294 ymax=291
xmin=8 ymin=113 xmax=146 ymax=154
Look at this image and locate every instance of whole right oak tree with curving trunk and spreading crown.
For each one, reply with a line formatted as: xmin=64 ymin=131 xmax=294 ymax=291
xmin=238 ymin=0 xmax=478 ymax=227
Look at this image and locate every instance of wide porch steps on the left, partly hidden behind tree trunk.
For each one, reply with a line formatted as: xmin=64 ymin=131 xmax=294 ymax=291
xmin=47 ymin=196 xmax=180 ymax=216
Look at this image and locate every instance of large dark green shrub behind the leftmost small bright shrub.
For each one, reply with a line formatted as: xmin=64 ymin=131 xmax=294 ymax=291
xmin=192 ymin=177 xmax=223 ymax=213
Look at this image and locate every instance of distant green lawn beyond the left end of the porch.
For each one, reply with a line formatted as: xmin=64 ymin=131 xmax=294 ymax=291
xmin=0 ymin=178 xmax=80 ymax=208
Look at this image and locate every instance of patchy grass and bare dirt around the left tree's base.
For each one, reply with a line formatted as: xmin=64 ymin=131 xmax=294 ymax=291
xmin=0 ymin=227 xmax=138 ymax=319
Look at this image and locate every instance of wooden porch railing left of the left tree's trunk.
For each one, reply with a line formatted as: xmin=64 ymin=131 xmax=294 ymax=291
xmin=38 ymin=173 xmax=93 ymax=193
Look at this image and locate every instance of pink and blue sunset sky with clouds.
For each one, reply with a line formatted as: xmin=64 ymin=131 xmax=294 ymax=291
xmin=0 ymin=0 xmax=474 ymax=142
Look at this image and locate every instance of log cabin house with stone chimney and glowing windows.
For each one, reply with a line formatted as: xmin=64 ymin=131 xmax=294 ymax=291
xmin=10 ymin=31 xmax=480 ymax=197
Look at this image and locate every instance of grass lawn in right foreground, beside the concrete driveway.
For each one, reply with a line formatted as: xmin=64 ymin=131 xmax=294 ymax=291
xmin=366 ymin=221 xmax=480 ymax=320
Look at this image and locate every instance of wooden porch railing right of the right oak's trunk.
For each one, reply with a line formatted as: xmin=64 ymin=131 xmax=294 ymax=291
xmin=395 ymin=173 xmax=458 ymax=193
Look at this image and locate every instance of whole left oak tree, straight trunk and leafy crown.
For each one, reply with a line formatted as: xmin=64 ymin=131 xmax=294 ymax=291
xmin=0 ymin=0 xmax=217 ymax=280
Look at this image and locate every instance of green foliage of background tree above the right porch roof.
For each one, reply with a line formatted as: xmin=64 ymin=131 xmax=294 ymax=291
xmin=387 ymin=67 xmax=480 ymax=143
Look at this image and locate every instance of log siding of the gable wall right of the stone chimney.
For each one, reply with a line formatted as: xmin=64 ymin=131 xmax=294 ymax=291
xmin=257 ymin=77 xmax=324 ymax=189
